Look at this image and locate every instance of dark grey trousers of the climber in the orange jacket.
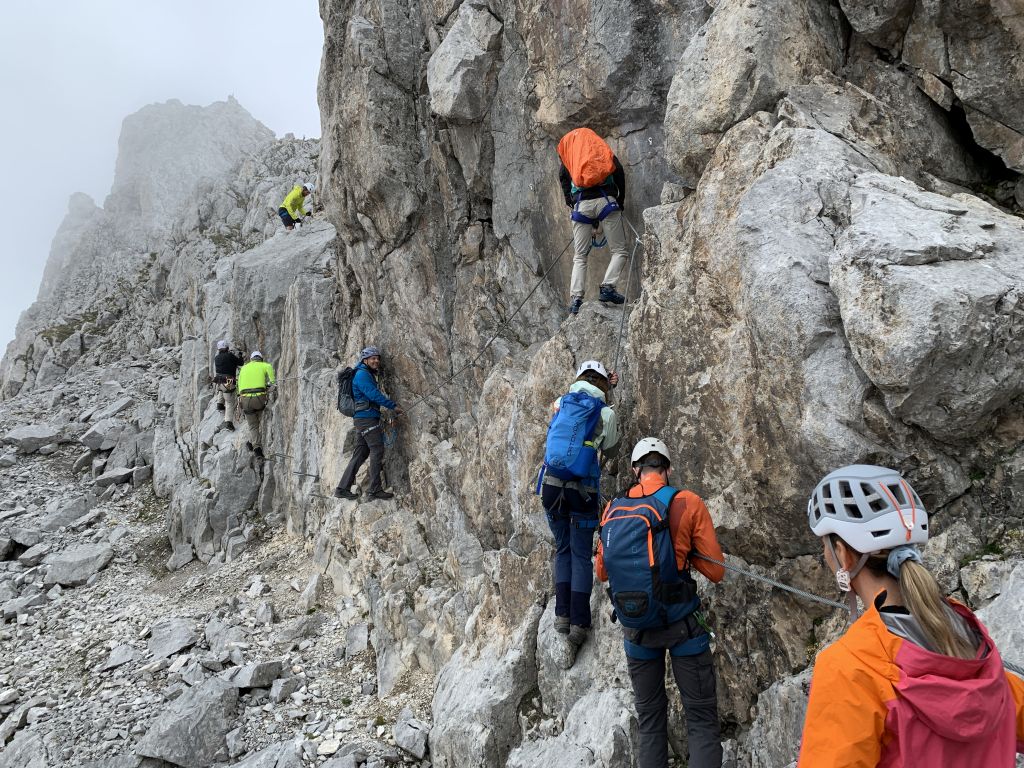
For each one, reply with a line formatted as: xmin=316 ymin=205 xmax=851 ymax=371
xmin=626 ymin=650 xmax=722 ymax=768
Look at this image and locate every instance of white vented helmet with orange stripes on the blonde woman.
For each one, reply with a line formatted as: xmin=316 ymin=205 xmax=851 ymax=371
xmin=807 ymin=464 xmax=928 ymax=555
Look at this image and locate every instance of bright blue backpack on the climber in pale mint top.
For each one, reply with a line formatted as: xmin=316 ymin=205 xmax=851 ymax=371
xmin=544 ymin=392 xmax=604 ymax=480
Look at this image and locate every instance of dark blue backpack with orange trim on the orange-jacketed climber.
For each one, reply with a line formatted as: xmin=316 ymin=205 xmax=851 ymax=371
xmin=600 ymin=485 xmax=700 ymax=630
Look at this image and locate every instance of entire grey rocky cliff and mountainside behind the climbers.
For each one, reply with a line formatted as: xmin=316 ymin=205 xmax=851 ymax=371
xmin=0 ymin=0 xmax=1024 ymax=768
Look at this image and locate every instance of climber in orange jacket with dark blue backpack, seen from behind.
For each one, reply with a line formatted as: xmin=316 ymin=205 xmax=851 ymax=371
xmin=597 ymin=437 xmax=725 ymax=768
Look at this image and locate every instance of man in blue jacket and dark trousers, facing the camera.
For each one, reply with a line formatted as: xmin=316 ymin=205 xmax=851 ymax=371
xmin=334 ymin=347 xmax=403 ymax=500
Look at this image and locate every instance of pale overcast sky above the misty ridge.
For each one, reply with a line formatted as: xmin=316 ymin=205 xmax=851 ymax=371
xmin=0 ymin=0 xmax=324 ymax=355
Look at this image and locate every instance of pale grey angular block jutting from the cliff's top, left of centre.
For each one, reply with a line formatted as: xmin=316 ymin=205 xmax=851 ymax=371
xmin=427 ymin=2 xmax=502 ymax=122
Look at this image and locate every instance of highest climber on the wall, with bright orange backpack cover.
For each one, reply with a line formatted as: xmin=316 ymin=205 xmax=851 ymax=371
xmin=558 ymin=128 xmax=626 ymax=314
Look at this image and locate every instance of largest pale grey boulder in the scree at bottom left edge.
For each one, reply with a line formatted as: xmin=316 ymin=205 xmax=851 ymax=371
xmin=135 ymin=678 xmax=239 ymax=768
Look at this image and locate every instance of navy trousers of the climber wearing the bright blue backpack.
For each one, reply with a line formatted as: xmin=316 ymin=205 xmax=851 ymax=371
xmin=541 ymin=484 xmax=599 ymax=627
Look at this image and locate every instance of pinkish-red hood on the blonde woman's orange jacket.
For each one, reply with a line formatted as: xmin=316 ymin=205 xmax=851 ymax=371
xmin=872 ymin=603 xmax=1011 ymax=743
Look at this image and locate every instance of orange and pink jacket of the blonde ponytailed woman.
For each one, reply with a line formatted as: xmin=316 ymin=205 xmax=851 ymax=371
xmin=799 ymin=601 xmax=1024 ymax=768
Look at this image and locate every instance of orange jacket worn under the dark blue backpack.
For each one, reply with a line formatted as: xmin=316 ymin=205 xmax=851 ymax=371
xmin=597 ymin=474 xmax=725 ymax=584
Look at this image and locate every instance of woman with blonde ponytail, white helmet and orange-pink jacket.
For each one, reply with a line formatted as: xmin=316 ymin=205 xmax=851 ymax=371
xmin=799 ymin=465 xmax=1024 ymax=768
